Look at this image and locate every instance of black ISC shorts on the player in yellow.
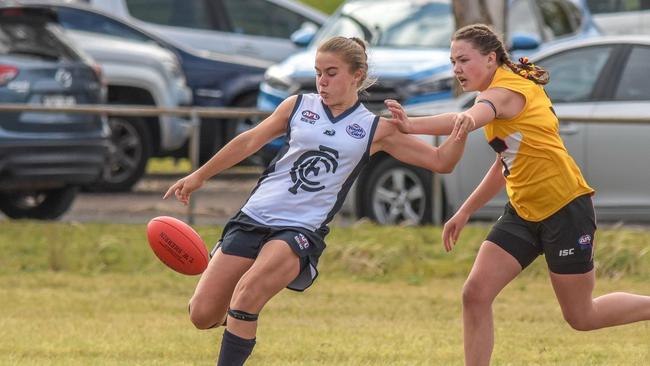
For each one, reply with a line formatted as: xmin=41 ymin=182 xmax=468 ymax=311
xmin=486 ymin=194 xmax=596 ymax=274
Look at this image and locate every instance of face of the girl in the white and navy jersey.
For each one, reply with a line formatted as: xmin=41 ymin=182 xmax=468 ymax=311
xmin=315 ymin=52 xmax=361 ymax=106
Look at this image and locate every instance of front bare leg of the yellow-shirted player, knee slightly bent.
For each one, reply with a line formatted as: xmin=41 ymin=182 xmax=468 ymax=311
xmin=463 ymin=241 xmax=521 ymax=366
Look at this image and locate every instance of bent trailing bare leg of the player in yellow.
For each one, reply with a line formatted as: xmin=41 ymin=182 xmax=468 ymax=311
xmin=550 ymin=270 xmax=650 ymax=331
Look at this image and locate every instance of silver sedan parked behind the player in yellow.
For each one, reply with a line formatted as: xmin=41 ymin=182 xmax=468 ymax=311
xmin=354 ymin=36 xmax=650 ymax=223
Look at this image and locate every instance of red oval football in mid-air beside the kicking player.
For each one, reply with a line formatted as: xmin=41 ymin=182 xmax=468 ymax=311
xmin=147 ymin=216 xmax=208 ymax=275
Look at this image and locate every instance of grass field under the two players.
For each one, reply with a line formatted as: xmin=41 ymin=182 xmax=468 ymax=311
xmin=0 ymin=222 xmax=650 ymax=366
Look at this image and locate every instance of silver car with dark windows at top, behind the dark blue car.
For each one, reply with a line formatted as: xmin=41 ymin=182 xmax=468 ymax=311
xmin=85 ymin=0 xmax=327 ymax=62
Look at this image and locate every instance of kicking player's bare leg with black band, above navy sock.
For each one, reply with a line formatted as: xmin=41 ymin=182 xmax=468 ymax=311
xmin=228 ymin=240 xmax=300 ymax=339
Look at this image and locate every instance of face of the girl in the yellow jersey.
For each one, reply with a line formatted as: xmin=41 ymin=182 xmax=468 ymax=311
xmin=449 ymin=40 xmax=498 ymax=92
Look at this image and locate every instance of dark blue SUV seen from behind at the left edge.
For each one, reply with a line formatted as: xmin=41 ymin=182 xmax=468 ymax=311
xmin=0 ymin=4 xmax=110 ymax=219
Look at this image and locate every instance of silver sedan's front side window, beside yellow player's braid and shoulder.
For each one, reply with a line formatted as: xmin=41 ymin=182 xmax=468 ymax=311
xmin=538 ymin=46 xmax=613 ymax=102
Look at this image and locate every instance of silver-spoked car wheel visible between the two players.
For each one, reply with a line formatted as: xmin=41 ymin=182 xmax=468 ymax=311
xmin=363 ymin=159 xmax=432 ymax=225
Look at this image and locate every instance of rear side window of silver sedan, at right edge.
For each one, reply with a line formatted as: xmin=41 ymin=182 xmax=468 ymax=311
xmin=614 ymin=46 xmax=650 ymax=101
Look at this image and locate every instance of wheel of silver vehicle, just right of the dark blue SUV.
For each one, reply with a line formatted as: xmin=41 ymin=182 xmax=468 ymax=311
xmin=93 ymin=117 xmax=151 ymax=192
